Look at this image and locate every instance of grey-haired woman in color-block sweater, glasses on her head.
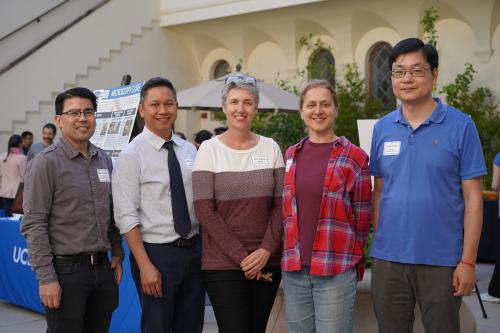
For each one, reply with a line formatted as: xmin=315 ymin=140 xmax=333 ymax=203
xmin=193 ymin=76 xmax=284 ymax=333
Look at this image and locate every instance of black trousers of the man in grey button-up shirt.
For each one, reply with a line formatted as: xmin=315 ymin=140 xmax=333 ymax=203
xmin=45 ymin=255 xmax=118 ymax=333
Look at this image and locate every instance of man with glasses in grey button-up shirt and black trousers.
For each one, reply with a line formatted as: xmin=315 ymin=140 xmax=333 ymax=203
xmin=21 ymin=88 xmax=123 ymax=333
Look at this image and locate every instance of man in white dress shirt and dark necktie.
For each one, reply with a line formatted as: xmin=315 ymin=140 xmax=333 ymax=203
xmin=112 ymin=78 xmax=205 ymax=333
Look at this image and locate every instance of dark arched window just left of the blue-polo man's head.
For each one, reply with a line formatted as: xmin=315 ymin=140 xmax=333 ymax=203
xmin=368 ymin=42 xmax=396 ymax=110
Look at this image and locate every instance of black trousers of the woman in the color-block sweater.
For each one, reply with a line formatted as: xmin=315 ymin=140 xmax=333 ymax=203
xmin=203 ymin=267 xmax=281 ymax=333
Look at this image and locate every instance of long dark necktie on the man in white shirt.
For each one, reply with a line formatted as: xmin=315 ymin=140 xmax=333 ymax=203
xmin=163 ymin=141 xmax=191 ymax=238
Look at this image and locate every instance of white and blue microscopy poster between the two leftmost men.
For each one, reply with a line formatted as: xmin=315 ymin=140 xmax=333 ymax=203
xmin=90 ymin=81 xmax=144 ymax=163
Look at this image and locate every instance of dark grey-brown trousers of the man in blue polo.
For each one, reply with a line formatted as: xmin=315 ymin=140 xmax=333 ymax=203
xmin=371 ymin=258 xmax=462 ymax=333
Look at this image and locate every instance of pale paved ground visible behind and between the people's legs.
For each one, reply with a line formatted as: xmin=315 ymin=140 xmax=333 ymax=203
xmin=0 ymin=264 xmax=500 ymax=333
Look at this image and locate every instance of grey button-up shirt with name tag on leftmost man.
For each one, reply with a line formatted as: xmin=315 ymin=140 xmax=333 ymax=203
xmin=21 ymin=137 xmax=123 ymax=284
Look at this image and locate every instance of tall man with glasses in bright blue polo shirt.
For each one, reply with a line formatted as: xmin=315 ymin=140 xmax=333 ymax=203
xmin=370 ymin=38 xmax=486 ymax=333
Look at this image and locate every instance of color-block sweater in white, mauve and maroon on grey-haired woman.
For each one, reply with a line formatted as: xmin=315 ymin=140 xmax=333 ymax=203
xmin=193 ymin=136 xmax=284 ymax=270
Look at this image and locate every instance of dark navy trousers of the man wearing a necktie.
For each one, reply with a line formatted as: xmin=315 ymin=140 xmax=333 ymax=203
xmin=130 ymin=240 xmax=205 ymax=333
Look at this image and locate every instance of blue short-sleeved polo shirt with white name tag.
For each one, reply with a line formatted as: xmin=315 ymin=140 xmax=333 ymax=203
xmin=370 ymin=99 xmax=486 ymax=266
